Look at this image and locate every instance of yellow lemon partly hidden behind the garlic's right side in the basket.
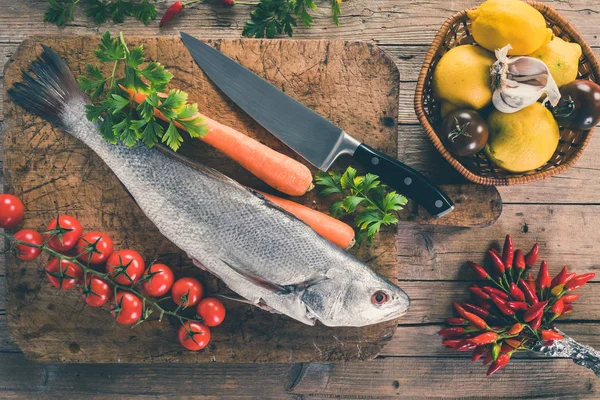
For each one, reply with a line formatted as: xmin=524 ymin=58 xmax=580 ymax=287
xmin=530 ymin=37 xmax=581 ymax=87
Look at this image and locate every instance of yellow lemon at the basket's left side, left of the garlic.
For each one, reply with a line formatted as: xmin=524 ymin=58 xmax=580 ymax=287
xmin=433 ymin=45 xmax=495 ymax=110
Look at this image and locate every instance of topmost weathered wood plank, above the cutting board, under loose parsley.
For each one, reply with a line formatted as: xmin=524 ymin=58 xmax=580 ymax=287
xmin=0 ymin=0 xmax=600 ymax=46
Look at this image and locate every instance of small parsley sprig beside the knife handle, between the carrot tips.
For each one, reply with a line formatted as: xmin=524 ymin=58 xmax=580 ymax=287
xmin=315 ymin=167 xmax=408 ymax=243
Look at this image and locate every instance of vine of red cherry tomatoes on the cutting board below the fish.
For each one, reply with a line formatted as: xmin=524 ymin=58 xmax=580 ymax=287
xmin=0 ymin=194 xmax=226 ymax=351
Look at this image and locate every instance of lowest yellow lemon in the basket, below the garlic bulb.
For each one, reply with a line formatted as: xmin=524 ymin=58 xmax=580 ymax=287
xmin=485 ymin=103 xmax=560 ymax=172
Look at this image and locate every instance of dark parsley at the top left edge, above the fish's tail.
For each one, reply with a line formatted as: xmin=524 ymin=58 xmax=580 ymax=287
xmin=44 ymin=0 xmax=156 ymax=26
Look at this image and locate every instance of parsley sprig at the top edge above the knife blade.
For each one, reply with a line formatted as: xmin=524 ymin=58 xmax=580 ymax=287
xmin=242 ymin=0 xmax=341 ymax=38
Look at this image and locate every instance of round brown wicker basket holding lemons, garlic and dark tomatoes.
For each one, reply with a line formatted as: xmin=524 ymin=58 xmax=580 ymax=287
xmin=415 ymin=1 xmax=600 ymax=186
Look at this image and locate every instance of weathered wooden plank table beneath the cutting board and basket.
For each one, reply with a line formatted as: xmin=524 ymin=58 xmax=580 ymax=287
xmin=0 ymin=0 xmax=600 ymax=399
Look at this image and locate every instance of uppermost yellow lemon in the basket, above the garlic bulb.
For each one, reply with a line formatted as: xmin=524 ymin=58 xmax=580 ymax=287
xmin=467 ymin=0 xmax=552 ymax=56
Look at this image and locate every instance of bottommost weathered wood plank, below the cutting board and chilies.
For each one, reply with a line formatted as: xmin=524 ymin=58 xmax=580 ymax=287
xmin=0 ymin=354 xmax=598 ymax=399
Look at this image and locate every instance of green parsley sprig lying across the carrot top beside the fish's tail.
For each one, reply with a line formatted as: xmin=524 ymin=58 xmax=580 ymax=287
xmin=78 ymin=31 xmax=206 ymax=151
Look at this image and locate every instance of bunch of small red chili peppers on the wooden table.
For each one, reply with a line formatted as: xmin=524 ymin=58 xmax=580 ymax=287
xmin=439 ymin=235 xmax=595 ymax=376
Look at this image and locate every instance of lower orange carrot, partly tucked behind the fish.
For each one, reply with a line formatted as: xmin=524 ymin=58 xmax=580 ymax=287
xmin=257 ymin=190 xmax=355 ymax=250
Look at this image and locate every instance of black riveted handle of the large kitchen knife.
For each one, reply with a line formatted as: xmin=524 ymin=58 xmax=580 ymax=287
xmin=354 ymin=144 xmax=454 ymax=218
